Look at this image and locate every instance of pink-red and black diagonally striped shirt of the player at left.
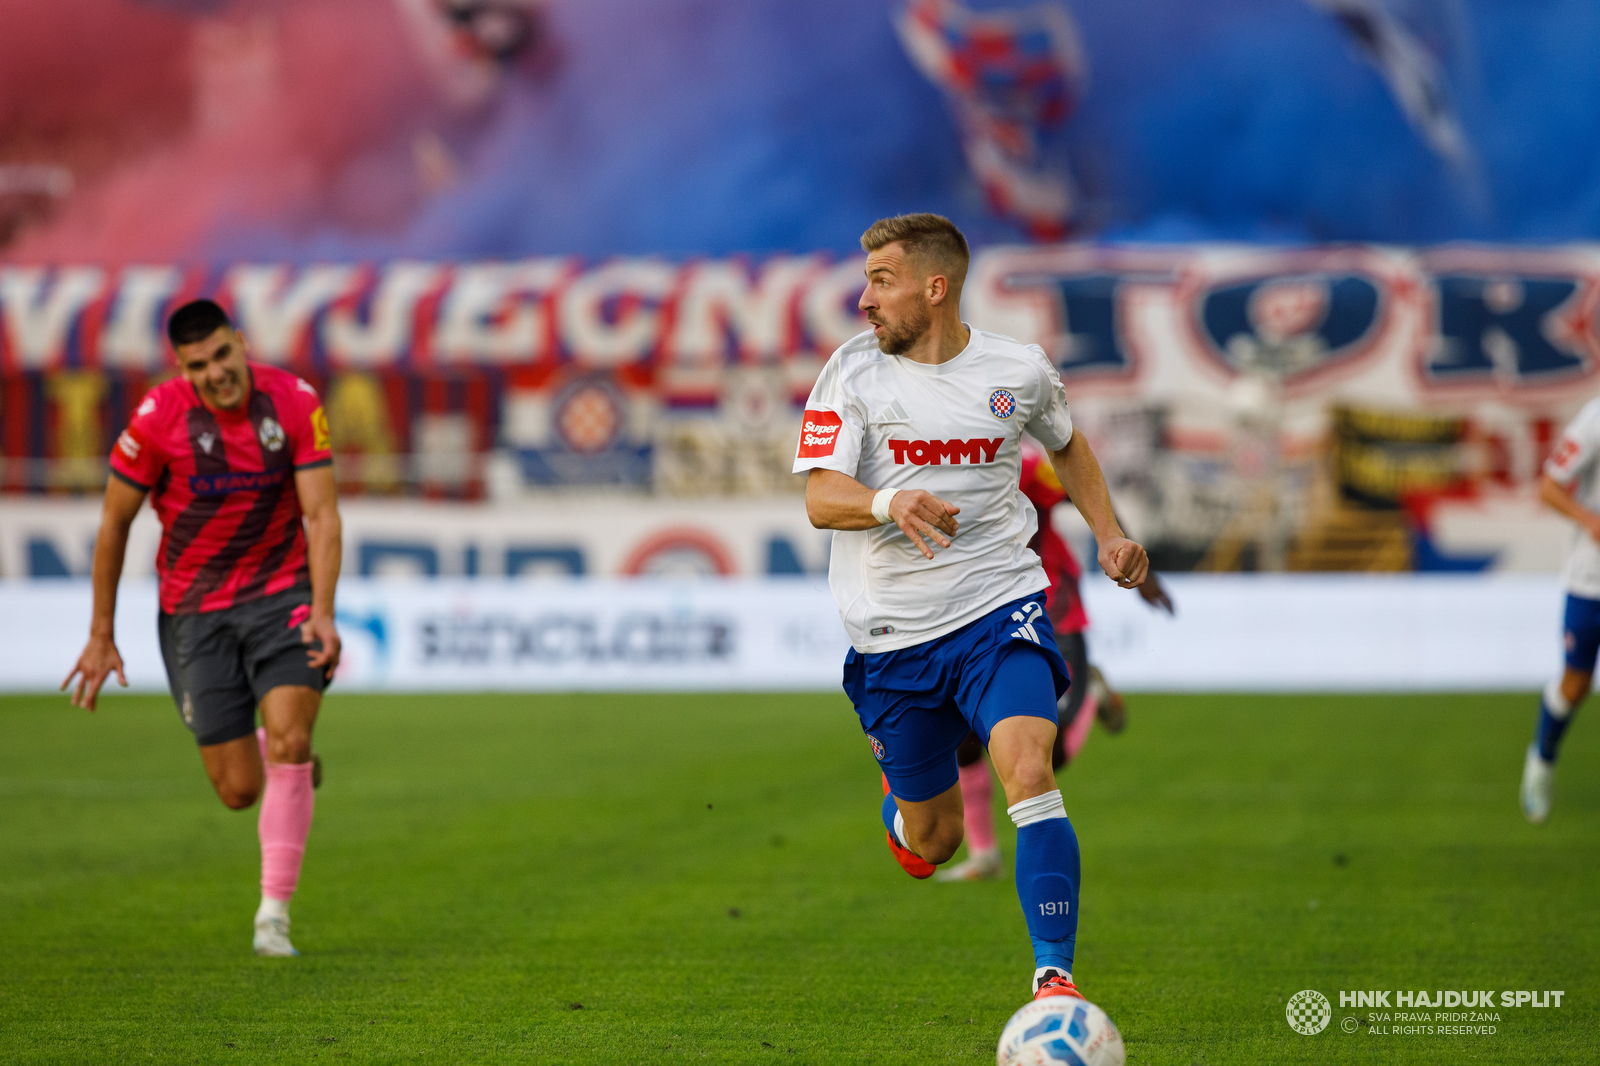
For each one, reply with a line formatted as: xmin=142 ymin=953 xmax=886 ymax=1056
xmin=110 ymin=363 xmax=333 ymax=615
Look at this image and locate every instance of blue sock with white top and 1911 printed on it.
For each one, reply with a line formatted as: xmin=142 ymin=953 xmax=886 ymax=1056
xmin=1008 ymin=792 xmax=1082 ymax=973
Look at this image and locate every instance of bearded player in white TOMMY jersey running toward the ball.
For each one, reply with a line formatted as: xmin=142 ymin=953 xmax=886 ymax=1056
xmin=795 ymin=214 xmax=1149 ymax=997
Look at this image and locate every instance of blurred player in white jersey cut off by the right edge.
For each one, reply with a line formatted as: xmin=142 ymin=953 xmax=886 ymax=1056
xmin=1522 ymin=399 xmax=1600 ymax=823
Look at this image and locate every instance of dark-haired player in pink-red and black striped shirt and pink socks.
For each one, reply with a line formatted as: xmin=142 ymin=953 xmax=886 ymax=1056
xmin=61 ymin=299 xmax=341 ymax=956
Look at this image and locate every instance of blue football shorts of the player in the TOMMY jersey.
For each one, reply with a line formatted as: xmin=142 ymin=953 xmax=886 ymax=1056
xmin=845 ymin=592 xmax=1070 ymax=802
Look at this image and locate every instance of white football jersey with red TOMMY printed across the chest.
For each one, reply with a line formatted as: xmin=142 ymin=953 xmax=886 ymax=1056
xmin=795 ymin=330 xmax=1072 ymax=651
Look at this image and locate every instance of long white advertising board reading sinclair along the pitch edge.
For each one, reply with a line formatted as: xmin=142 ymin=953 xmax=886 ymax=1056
xmin=0 ymin=575 xmax=1562 ymax=691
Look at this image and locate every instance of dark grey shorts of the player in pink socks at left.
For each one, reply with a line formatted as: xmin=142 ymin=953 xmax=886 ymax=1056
xmin=157 ymin=589 xmax=326 ymax=746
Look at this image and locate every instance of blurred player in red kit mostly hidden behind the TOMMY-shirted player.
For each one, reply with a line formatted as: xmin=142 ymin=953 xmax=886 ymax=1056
xmin=934 ymin=447 xmax=1173 ymax=880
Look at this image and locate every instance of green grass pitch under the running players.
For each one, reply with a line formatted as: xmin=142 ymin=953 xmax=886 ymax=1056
xmin=0 ymin=695 xmax=1600 ymax=1064
